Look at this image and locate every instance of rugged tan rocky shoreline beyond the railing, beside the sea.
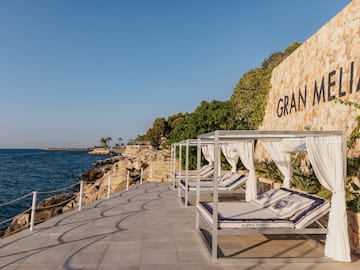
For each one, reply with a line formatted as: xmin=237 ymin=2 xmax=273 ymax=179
xmin=0 ymin=146 xmax=171 ymax=237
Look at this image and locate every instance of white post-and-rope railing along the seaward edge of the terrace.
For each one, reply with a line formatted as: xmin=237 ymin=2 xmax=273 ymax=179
xmin=0 ymin=169 xmax=146 ymax=236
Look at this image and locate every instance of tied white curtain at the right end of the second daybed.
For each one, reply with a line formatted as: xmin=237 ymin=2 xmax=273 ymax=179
xmin=237 ymin=141 xmax=257 ymax=201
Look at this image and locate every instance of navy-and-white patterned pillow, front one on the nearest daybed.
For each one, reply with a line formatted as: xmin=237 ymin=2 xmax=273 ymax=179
xmin=269 ymin=194 xmax=314 ymax=219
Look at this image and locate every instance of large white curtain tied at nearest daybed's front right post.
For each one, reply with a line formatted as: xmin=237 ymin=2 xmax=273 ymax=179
xmin=306 ymin=136 xmax=351 ymax=262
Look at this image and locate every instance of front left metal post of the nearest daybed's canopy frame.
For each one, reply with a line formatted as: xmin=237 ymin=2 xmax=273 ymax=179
xmin=211 ymin=131 xmax=220 ymax=262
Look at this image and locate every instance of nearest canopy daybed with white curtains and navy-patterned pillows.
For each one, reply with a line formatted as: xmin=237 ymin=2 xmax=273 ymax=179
xmin=196 ymin=131 xmax=351 ymax=262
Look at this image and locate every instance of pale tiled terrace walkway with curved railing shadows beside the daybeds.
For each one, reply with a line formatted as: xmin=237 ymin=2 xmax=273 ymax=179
xmin=0 ymin=183 xmax=360 ymax=270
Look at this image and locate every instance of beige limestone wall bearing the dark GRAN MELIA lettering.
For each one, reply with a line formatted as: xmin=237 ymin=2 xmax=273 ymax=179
xmin=260 ymin=0 xmax=360 ymax=155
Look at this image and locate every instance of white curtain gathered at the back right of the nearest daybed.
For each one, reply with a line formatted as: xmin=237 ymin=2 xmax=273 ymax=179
xmin=263 ymin=141 xmax=292 ymax=188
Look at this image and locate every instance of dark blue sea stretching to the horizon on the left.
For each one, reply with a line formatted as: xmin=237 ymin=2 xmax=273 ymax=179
xmin=0 ymin=149 xmax=107 ymax=228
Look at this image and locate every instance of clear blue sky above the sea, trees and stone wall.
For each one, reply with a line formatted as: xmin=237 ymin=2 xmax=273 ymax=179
xmin=0 ymin=0 xmax=350 ymax=147
